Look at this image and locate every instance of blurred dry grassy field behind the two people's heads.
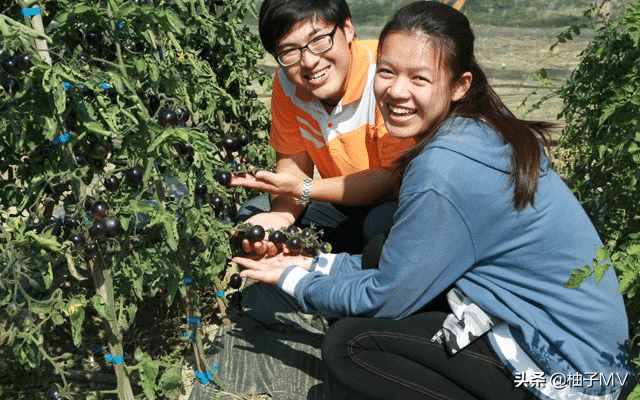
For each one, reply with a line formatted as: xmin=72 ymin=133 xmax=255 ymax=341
xmin=248 ymin=0 xmax=625 ymax=126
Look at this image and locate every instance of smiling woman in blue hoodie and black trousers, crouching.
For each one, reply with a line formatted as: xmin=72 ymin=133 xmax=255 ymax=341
xmin=235 ymin=1 xmax=633 ymax=400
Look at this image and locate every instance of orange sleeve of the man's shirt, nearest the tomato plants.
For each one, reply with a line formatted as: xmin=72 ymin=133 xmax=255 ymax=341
xmin=269 ymin=71 xmax=306 ymax=154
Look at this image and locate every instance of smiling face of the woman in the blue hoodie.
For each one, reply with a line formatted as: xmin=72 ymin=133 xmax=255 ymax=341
xmin=374 ymin=32 xmax=471 ymax=138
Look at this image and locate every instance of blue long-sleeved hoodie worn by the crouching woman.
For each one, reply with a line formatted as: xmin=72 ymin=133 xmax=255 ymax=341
xmin=279 ymin=117 xmax=629 ymax=396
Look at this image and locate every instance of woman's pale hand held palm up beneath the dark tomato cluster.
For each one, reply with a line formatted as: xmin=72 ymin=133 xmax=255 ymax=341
xmin=232 ymin=253 xmax=313 ymax=285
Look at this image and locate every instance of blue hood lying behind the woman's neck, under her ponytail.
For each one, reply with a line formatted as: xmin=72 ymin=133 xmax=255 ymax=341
xmin=425 ymin=117 xmax=549 ymax=176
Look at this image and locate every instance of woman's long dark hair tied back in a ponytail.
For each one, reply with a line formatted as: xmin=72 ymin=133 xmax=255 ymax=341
xmin=378 ymin=1 xmax=555 ymax=210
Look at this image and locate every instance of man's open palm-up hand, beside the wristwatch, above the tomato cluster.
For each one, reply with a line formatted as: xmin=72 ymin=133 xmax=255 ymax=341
xmin=231 ymin=171 xmax=306 ymax=197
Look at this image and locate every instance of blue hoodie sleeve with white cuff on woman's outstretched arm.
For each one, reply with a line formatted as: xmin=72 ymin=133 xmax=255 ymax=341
xmin=279 ymin=189 xmax=475 ymax=318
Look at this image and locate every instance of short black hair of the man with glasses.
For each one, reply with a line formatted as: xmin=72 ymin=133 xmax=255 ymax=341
xmin=258 ymin=0 xmax=351 ymax=54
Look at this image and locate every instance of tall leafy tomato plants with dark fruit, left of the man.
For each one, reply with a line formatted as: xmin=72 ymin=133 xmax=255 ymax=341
xmin=0 ymin=0 xmax=274 ymax=399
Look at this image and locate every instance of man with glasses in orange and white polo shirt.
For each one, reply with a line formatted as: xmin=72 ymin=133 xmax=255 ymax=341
xmin=232 ymin=0 xmax=415 ymax=255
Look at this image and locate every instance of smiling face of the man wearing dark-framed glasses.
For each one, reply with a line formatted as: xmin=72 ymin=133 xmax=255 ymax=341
xmin=276 ymin=18 xmax=354 ymax=106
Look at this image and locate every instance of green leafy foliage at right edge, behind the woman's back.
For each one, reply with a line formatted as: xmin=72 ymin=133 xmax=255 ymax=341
xmin=559 ymin=1 xmax=640 ymax=372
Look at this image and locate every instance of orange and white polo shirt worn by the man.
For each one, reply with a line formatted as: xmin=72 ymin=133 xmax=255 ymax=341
xmin=270 ymin=40 xmax=415 ymax=178
